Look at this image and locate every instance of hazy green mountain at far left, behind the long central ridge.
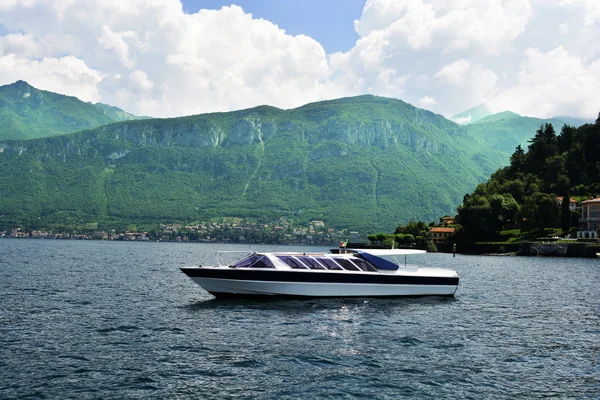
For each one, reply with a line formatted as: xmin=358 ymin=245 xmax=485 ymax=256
xmin=0 ymin=81 xmax=142 ymax=140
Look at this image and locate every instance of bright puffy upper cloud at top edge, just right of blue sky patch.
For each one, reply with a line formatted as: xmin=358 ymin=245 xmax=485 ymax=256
xmin=354 ymin=0 xmax=533 ymax=52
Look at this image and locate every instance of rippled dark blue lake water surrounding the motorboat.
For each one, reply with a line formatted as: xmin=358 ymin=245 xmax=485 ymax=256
xmin=0 ymin=239 xmax=600 ymax=399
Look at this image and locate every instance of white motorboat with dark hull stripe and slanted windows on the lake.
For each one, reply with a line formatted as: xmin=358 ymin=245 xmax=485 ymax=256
xmin=181 ymin=249 xmax=459 ymax=297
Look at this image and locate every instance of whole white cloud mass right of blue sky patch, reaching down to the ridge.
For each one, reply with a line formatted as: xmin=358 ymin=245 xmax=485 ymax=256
xmin=330 ymin=0 xmax=600 ymax=117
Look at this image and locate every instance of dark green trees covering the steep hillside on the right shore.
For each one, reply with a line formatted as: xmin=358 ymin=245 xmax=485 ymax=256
xmin=457 ymin=113 xmax=600 ymax=239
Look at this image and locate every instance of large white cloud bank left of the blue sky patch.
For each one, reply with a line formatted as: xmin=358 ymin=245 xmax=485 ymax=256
xmin=0 ymin=0 xmax=329 ymax=116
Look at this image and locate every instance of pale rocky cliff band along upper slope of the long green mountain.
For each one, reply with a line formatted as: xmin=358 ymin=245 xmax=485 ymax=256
xmin=0 ymin=110 xmax=452 ymax=168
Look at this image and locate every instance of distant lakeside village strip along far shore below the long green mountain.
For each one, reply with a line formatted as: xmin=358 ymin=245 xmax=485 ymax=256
xmin=0 ymin=217 xmax=365 ymax=245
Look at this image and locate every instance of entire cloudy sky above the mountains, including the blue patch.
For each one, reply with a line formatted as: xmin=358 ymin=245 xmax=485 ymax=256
xmin=0 ymin=0 xmax=600 ymax=120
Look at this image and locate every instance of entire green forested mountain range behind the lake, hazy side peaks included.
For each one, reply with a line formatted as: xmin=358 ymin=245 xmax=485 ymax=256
xmin=0 ymin=81 xmax=592 ymax=234
